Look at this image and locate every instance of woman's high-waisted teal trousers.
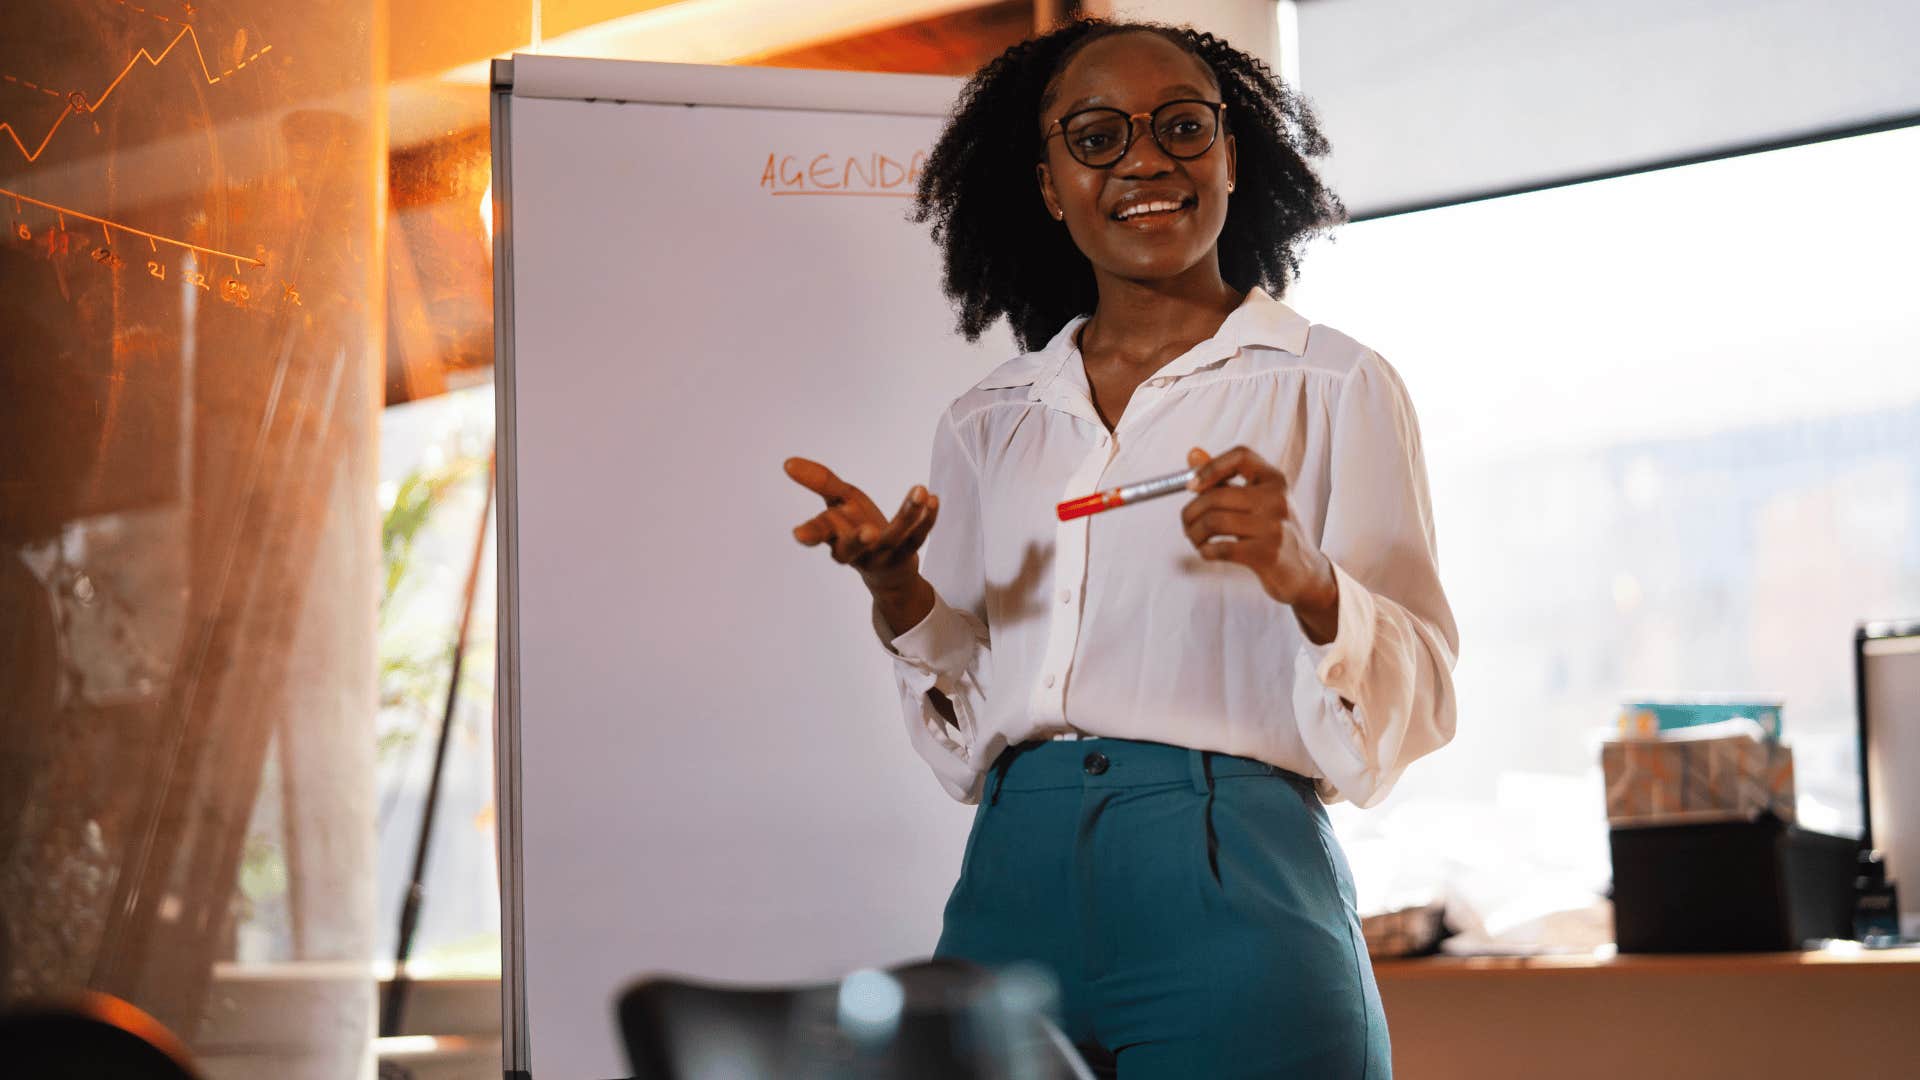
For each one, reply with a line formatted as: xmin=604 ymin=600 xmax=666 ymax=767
xmin=935 ymin=738 xmax=1392 ymax=1080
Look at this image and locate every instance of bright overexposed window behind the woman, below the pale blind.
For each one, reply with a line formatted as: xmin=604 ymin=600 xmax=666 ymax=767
xmin=1288 ymin=119 xmax=1920 ymax=933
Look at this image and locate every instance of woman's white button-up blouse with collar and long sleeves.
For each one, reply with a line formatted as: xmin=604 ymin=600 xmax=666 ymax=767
xmin=874 ymin=288 xmax=1459 ymax=807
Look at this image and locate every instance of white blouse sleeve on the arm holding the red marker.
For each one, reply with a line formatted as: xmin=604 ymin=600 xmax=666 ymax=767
xmin=1292 ymin=354 xmax=1459 ymax=807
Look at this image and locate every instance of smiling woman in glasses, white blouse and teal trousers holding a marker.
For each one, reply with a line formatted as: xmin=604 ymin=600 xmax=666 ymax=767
xmin=787 ymin=21 xmax=1455 ymax=1078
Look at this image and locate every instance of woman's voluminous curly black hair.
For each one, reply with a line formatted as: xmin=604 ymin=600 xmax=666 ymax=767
xmin=912 ymin=19 xmax=1346 ymax=350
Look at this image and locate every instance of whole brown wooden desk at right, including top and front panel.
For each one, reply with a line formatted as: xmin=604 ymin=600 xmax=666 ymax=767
xmin=1375 ymin=945 xmax=1920 ymax=1080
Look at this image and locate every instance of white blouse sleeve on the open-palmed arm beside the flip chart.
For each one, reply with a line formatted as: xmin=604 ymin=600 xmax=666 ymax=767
xmin=874 ymin=411 xmax=991 ymax=803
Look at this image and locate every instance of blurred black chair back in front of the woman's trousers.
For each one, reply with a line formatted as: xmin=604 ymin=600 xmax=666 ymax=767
xmin=618 ymin=959 xmax=1089 ymax=1080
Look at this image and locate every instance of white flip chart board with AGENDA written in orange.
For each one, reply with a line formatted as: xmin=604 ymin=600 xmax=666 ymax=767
xmin=493 ymin=56 xmax=1016 ymax=1080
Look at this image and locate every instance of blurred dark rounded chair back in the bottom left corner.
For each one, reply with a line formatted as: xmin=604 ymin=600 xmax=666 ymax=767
xmin=0 ymin=994 xmax=200 ymax=1080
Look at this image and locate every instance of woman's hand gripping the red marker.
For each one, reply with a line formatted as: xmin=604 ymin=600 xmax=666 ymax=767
xmin=1181 ymin=446 xmax=1340 ymax=644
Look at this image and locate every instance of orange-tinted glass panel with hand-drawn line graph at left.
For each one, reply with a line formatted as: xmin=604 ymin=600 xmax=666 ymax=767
xmin=0 ymin=0 xmax=386 ymax=1076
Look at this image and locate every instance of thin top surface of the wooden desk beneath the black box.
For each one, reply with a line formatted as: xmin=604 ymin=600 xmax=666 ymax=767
xmin=1373 ymin=942 xmax=1920 ymax=982
